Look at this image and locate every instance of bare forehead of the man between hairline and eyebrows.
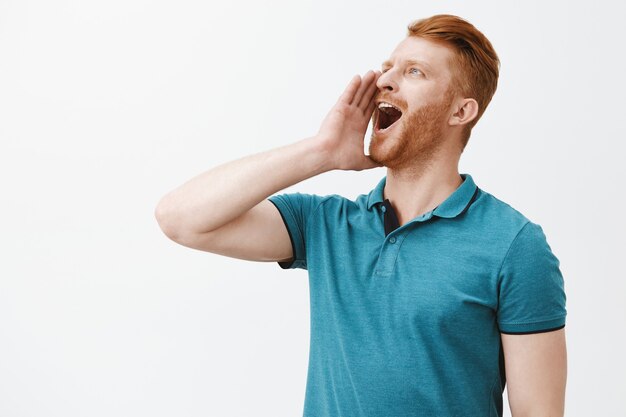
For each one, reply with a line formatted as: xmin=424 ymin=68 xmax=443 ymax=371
xmin=382 ymin=36 xmax=452 ymax=77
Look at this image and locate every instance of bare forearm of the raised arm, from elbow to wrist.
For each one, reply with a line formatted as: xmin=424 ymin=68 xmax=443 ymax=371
xmin=155 ymin=136 xmax=334 ymax=235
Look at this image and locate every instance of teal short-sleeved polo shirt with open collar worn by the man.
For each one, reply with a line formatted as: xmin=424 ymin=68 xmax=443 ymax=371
xmin=268 ymin=174 xmax=566 ymax=417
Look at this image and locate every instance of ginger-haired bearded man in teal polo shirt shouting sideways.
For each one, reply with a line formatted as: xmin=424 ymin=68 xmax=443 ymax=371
xmin=156 ymin=15 xmax=566 ymax=417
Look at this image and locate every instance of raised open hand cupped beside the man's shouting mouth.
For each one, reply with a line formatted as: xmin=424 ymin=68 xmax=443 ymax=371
xmin=317 ymin=70 xmax=382 ymax=171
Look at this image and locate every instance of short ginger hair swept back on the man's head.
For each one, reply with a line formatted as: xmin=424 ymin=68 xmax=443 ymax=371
xmin=407 ymin=14 xmax=500 ymax=148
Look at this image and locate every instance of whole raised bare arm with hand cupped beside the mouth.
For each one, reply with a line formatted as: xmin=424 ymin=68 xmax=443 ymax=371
xmin=155 ymin=71 xmax=380 ymax=260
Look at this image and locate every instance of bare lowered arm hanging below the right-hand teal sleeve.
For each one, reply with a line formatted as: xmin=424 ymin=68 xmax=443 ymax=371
xmin=501 ymin=328 xmax=567 ymax=417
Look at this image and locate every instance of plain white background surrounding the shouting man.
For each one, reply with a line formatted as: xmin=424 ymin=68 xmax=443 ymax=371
xmin=0 ymin=0 xmax=626 ymax=417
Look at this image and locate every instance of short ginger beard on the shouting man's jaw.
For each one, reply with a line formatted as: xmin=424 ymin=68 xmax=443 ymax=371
xmin=369 ymin=91 xmax=454 ymax=173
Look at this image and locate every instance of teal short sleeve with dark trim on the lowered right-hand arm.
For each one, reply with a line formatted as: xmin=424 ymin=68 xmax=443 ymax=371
xmin=497 ymin=221 xmax=567 ymax=334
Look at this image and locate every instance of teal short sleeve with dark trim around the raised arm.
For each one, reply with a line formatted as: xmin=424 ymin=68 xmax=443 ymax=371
xmin=268 ymin=193 xmax=323 ymax=269
